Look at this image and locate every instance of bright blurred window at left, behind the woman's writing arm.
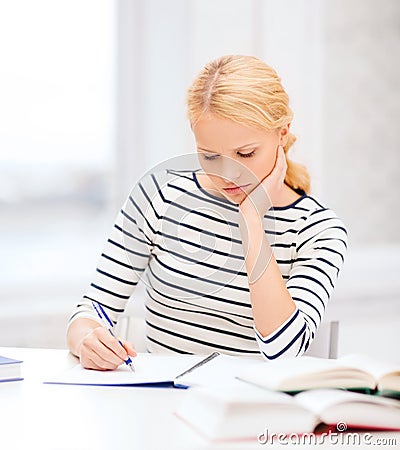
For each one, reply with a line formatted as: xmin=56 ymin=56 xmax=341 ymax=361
xmin=0 ymin=0 xmax=115 ymax=346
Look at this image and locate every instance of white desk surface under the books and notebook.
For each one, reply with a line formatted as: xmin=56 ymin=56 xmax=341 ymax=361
xmin=0 ymin=347 xmax=400 ymax=450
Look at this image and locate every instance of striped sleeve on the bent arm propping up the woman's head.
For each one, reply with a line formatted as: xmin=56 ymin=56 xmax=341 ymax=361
xmin=255 ymin=209 xmax=347 ymax=360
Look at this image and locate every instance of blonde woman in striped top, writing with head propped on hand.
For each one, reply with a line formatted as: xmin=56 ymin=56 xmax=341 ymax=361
xmin=68 ymin=56 xmax=347 ymax=370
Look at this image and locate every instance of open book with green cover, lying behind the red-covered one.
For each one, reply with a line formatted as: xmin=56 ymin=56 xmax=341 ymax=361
xmin=238 ymin=354 xmax=400 ymax=396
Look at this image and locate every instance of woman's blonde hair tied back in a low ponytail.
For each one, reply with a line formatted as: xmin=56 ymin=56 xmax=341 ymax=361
xmin=187 ymin=55 xmax=310 ymax=193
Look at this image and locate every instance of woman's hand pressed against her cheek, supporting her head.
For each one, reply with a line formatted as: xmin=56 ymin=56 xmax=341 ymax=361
xmin=239 ymin=146 xmax=287 ymax=217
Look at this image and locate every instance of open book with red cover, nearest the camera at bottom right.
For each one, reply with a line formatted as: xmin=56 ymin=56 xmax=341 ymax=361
xmin=175 ymin=385 xmax=400 ymax=444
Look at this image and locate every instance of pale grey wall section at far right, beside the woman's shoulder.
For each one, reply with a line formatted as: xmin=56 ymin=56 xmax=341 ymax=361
xmin=323 ymin=0 xmax=400 ymax=246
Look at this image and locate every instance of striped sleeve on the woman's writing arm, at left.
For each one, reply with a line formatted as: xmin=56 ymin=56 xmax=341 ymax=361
xmin=69 ymin=172 xmax=159 ymax=323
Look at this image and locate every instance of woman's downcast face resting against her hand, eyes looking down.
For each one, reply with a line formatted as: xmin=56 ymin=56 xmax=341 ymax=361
xmin=193 ymin=115 xmax=289 ymax=203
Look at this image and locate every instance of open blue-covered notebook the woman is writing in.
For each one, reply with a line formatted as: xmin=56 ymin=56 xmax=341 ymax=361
xmin=44 ymin=352 xmax=260 ymax=387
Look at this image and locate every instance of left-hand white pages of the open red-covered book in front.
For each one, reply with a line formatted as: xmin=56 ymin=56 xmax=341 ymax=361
xmin=175 ymin=383 xmax=318 ymax=442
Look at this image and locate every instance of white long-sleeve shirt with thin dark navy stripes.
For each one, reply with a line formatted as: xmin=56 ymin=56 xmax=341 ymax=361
xmin=71 ymin=170 xmax=347 ymax=360
